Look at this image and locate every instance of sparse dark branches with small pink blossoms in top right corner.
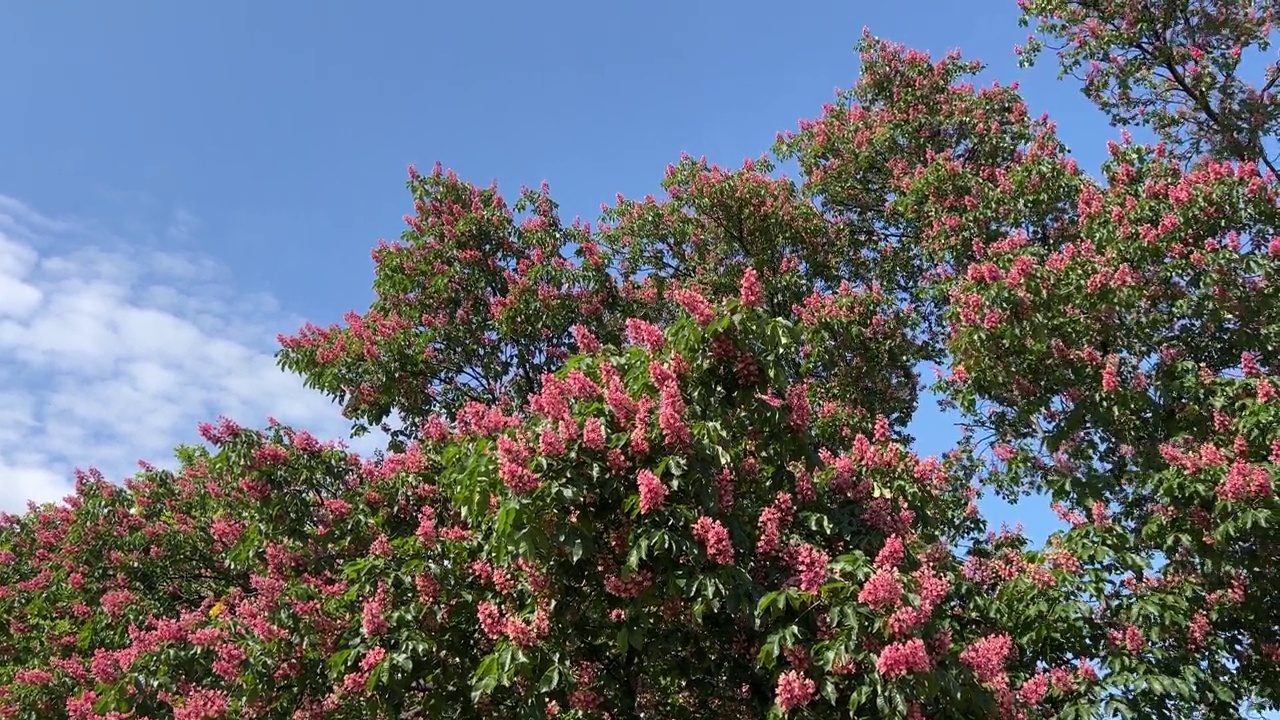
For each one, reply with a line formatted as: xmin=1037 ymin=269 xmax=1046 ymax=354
xmin=1019 ymin=0 xmax=1280 ymax=173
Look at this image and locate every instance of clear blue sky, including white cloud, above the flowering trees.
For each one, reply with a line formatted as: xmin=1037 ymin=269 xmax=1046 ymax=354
xmin=0 ymin=0 xmax=1116 ymax=536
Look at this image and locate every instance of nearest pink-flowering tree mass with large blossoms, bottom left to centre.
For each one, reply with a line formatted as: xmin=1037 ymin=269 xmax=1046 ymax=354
xmin=5 ymin=295 xmax=1096 ymax=717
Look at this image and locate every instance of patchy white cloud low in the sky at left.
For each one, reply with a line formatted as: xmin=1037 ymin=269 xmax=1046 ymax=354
xmin=0 ymin=195 xmax=378 ymax=512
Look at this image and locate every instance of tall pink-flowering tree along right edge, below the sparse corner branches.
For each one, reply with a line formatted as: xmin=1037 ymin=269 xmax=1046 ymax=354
xmin=948 ymin=133 xmax=1280 ymax=716
